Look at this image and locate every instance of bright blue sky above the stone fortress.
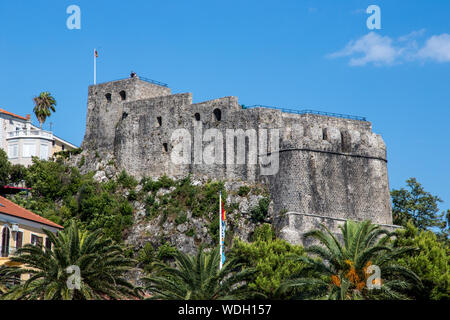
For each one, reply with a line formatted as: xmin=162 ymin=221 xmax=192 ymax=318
xmin=0 ymin=0 xmax=450 ymax=208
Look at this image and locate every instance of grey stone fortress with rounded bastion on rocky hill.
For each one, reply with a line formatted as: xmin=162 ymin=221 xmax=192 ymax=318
xmin=82 ymin=76 xmax=394 ymax=243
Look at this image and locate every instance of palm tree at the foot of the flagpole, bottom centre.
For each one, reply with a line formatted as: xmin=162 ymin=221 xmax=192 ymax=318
xmin=144 ymin=248 xmax=254 ymax=300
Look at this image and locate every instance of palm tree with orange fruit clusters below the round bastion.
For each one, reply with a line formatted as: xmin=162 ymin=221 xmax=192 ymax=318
xmin=282 ymin=221 xmax=421 ymax=300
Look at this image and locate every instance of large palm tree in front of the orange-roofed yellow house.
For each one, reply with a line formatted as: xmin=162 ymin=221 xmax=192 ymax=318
xmin=2 ymin=222 xmax=139 ymax=300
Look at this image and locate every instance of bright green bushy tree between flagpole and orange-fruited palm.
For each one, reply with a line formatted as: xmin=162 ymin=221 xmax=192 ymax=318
xmin=230 ymin=224 xmax=304 ymax=299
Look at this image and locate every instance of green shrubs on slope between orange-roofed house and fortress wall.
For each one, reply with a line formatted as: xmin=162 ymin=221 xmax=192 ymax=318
xmin=7 ymin=158 xmax=134 ymax=241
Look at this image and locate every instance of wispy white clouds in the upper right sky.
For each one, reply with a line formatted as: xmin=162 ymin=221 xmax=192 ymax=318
xmin=328 ymin=29 xmax=450 ymax=66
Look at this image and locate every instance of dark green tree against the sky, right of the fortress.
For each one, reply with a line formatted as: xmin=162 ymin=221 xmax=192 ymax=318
xmin=391 ymin=178 xmax=450 ymax=238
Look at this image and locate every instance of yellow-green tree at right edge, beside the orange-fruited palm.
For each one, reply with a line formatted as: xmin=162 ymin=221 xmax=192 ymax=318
xmin=395 ymin=223 xmax=450 ymax=300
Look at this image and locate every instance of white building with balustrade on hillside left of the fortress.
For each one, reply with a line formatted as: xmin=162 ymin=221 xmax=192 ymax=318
xmin=0 ymin=109 xmax=77 ymax=166
